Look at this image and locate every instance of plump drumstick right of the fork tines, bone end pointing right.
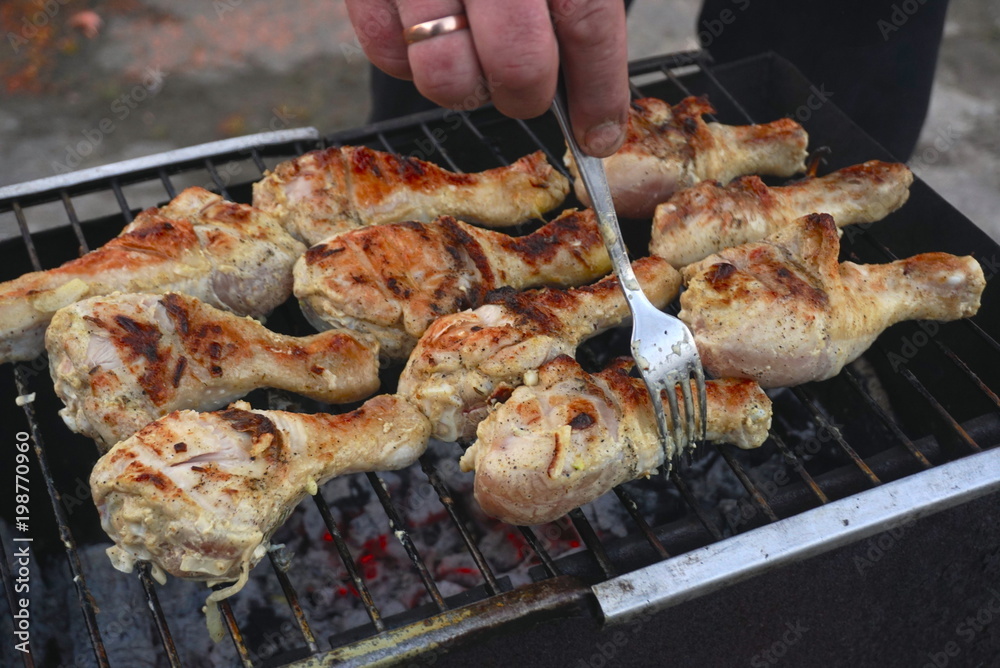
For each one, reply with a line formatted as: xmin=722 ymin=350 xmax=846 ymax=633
xmin=680 ymin=214 xmax=986 ymax=387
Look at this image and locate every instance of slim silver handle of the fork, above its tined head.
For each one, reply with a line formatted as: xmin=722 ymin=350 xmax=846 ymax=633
xmin=552 ymin=83 xmax=645 ymax=300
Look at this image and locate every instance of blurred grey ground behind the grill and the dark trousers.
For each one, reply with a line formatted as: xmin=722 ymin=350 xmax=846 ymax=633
xmin=0 ymin=0 xmax=1000 ymax=240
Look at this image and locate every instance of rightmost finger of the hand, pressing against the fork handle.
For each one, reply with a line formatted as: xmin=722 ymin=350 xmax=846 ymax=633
xmin=551 ymin=0 xmax=629 ymax=157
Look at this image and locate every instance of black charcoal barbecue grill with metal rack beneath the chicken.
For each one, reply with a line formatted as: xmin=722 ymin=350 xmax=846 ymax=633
xmin=0 ymin=52 xmax=1000 ymax=666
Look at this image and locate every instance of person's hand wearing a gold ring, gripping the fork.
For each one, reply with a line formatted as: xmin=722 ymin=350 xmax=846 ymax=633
xmin=347 ymin=0 xmax=629 ymax=157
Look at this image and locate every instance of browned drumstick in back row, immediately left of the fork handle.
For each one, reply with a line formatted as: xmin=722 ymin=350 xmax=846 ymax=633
xmin=253 ymin=146 xmax=569 ymax=245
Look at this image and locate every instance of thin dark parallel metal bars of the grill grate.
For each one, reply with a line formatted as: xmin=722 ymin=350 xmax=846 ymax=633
xmin=0 ymin=53 xmax=1000 ymax=667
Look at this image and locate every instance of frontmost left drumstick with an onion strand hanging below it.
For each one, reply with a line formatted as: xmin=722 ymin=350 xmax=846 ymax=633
xmin=90 ymin=395 xmax=430 ymax=611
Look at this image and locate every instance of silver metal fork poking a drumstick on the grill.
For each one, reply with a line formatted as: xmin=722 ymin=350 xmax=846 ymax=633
xmin=552 ymin=81 xmax=707 ymax=457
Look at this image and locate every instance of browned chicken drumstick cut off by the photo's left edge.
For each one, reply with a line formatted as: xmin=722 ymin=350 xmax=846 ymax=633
xmin=0 ymin=188 xmax=305 ymax=362
